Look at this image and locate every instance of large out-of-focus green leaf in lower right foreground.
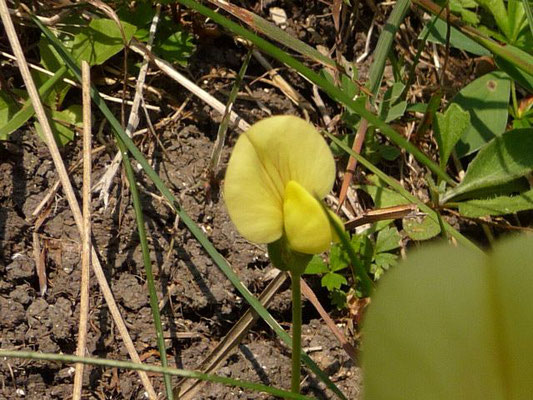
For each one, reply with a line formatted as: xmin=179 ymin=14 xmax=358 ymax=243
xmin=361 ymin=236 xmax=533 ymax=400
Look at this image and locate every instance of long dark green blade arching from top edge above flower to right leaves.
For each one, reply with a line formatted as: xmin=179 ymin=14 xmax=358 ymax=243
xmin=178 ymin=0 xmax=455 ymax=186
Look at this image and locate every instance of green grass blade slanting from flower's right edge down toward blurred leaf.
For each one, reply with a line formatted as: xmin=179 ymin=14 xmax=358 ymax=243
xmin=326 ymin=132 xmax=482 ymax=252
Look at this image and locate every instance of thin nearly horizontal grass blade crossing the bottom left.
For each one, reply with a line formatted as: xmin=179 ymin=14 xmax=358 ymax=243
xmin=0 ymin=350 xmax=313 ymax=400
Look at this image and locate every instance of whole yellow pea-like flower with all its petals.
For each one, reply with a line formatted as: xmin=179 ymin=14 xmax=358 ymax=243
xmin=224 ymin=116 xmax=340 ymax=254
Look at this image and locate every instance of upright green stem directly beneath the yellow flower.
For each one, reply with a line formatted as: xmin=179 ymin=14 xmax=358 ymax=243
xmin=291 ymin=272 xmax=302 ymax=394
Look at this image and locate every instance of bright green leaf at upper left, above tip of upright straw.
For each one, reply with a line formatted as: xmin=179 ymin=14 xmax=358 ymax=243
xmin=72 ymin=18 xmax=136 ymax=65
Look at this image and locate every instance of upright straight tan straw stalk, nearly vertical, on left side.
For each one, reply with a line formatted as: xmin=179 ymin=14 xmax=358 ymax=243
xmin=72 ymin=61 xmax=92 ymax=400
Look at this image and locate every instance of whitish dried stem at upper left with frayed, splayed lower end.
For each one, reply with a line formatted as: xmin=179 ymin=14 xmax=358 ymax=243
xmin=94 ymin=3 xmax=161 ymax=208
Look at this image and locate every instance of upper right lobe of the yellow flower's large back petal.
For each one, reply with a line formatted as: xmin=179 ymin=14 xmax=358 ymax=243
xmin=245 ymin=115 xmax=335 ymax=198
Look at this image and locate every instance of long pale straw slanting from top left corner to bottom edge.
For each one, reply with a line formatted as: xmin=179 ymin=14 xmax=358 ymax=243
xmin=0 ymin=0 xmax=157 ymax=399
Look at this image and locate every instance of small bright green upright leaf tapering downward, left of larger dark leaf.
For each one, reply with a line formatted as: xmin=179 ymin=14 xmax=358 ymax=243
xmin=435 ymin=103 xmax=470 ymax=168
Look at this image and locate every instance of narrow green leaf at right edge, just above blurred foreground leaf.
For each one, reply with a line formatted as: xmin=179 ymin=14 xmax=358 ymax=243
xmin=459 ymin=189 xmax=533 ymax=218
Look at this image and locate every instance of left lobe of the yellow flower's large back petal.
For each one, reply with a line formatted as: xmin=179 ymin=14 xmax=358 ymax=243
xmin=224 ymin=134 xmax=283 ymax=243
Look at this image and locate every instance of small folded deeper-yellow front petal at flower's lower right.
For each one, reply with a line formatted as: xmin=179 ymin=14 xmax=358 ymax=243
xmin=283 ymin=181 xmax=331 ymax=254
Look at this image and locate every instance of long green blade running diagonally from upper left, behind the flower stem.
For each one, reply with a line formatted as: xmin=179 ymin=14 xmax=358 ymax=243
xmin=32 ymin=16 xmax=346 ymax=399
